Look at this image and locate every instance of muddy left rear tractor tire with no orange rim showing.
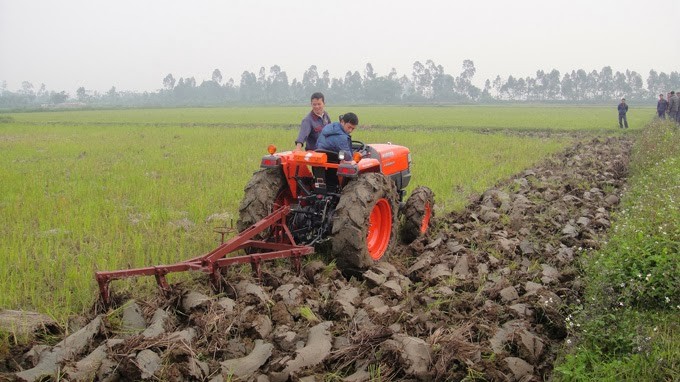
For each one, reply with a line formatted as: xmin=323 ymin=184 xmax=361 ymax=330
xmin=236 ymin=167 xmax=290 ymax=236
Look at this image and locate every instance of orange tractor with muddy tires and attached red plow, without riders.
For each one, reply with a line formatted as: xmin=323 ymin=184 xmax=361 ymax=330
xmin=96 ymin=141 xmax=434 ymax=305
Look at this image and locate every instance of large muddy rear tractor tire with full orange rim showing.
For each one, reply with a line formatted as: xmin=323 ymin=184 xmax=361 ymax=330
xmin=331 ymin=173 xmax=399 ymax=273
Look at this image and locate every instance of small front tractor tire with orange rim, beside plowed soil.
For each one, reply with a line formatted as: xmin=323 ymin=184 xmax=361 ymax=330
xmin=399 ymin=186 xmax=434 ymax=244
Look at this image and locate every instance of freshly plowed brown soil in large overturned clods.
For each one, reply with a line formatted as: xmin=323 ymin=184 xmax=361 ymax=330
xmin=0 ymin=138 xmax=632 ymax=381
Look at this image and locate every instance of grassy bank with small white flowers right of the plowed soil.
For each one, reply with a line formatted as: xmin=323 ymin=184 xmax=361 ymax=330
xmin=555 ymin=121 xmax=680 ymax=381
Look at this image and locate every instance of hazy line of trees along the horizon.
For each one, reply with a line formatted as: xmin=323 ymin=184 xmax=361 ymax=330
xmin=0 ymin=60 xmax=680 ymax=109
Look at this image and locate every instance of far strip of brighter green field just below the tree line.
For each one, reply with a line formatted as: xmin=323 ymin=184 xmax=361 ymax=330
xmin=3 ymin=105 xmax=655 ymax=132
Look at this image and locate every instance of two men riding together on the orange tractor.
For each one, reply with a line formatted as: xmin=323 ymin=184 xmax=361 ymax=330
xmin=294 ymin=92 xmax=359 ymax=158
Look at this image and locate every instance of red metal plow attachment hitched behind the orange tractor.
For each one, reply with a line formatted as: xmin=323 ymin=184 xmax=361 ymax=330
xmin=95 ymin=206 xmax=314 ymax=306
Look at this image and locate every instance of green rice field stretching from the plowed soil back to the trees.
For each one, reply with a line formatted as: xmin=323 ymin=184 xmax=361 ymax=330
xmin=0 ymin=106 xmax=654 ymax=320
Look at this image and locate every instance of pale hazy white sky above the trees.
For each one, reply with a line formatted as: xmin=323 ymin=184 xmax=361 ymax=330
xmin=0 ymin=0 xmax=680 ymax=95
